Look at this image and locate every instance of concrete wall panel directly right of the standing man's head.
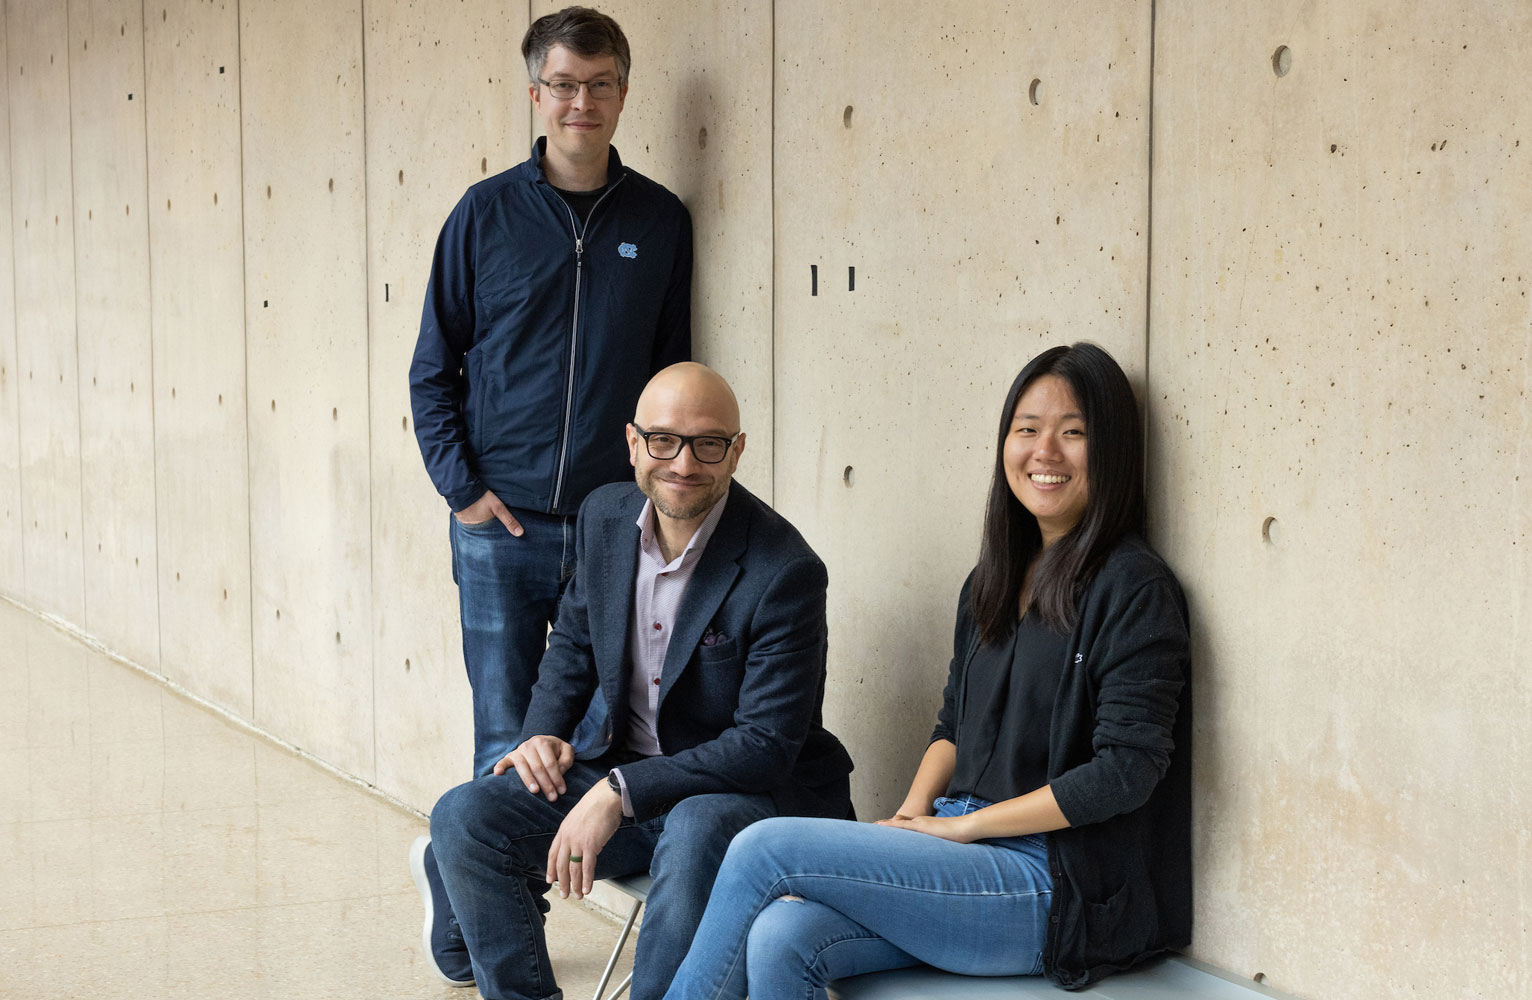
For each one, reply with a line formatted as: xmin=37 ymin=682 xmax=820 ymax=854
xmin=533 ymin=0 xmax=774 ymax=490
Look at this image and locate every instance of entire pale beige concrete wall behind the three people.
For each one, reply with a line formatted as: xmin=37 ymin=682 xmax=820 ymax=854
xmin=0 ymin=0 xmax=1532 ymax=1000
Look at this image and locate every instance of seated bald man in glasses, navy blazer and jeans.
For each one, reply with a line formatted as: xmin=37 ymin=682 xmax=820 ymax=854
xmin=430 ymin=363 xmax=852 ymax=1000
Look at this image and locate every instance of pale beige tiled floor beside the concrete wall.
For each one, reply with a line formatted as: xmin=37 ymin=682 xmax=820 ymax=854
xmin=0 ymin=600 xmax=631 ymax=1000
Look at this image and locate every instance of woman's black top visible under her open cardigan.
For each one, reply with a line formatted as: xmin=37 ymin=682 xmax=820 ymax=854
xmin=947 ymin=614 xmax=1069 ymax=802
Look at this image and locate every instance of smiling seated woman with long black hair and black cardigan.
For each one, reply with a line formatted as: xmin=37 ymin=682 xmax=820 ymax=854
xmin=666 ymin=343 xmax=1192 ymax=1000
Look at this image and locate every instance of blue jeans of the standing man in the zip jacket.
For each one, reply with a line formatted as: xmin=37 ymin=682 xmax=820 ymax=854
xmin=449 ymin=508 xmax=607 ymax=776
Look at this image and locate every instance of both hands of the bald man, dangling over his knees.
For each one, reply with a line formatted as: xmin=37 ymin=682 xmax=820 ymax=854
xmin=495 ymin=737 xmax=622 ymax=899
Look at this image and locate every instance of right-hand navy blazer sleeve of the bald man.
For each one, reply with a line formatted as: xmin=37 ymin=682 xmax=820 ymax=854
xmin=622 ymin=554 xmax=827 ymax=822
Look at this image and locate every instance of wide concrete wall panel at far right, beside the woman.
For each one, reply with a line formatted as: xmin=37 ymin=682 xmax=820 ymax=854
xmin=1149 ymin=2 xmax=1532 ymax=1000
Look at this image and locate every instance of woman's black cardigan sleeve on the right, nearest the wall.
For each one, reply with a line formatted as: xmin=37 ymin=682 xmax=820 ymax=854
xmin=1049 ymin=570 xmax=1190 ymax=827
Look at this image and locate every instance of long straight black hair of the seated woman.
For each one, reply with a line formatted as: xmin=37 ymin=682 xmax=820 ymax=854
xmin=973 ymin=342 xmax=1144 ymax=643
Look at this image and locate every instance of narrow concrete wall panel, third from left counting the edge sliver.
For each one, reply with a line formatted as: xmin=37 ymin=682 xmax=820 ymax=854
xmin=69 ymin=0 xmax=159 ymax=666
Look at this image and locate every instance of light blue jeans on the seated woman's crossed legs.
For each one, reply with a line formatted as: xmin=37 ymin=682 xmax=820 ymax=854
xmin=665 ymin=799 xmax=1052 ymax=1000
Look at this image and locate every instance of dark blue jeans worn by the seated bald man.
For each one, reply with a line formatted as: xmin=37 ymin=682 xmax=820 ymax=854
xmin=430 ymin=758 xmax=777 ymax=1000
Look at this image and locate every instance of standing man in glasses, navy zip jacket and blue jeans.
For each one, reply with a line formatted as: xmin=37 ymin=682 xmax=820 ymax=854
xmin=409 ymin=8 xmax=692 ymax=986
